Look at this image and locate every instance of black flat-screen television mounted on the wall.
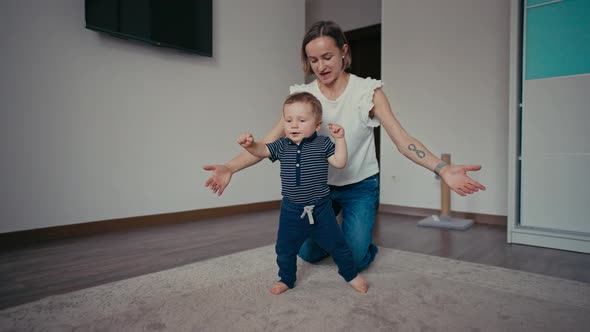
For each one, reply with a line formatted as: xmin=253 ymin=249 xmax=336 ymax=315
xmin=84 ymin=0 xmax=213 ymax=57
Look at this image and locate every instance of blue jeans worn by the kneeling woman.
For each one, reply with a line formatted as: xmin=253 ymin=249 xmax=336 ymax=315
xmin=299 ymin=174 xmax=379 ymax=271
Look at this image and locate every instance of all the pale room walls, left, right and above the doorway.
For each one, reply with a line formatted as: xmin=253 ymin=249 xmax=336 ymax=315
xmin=0 ymin=0 xmax=509 ymax=233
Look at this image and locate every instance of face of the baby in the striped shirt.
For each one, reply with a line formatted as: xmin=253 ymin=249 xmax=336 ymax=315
xmin=283 ymin=103 xmax=321 ymax=144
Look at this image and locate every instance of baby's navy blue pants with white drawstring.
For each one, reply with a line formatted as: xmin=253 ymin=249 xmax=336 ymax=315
xmin=275 ymin=196 xmax=357 ymax=288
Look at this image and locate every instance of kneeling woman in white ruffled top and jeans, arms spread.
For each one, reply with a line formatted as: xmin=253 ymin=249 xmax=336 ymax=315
xmin=203 ymin=21 xmax=485 ymax=271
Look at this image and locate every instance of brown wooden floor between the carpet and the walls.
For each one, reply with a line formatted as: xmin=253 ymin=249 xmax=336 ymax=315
xmin=0 ymin=211 xmax=590 ymax=309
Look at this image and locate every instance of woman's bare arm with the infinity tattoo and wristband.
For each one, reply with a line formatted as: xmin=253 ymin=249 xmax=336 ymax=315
xmin=373 ymin=89 xmax=485 ymax=196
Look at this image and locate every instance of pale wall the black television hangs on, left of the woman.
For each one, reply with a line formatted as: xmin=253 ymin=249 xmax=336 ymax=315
xmin=0 ymin=0 xmax=305 ymax=233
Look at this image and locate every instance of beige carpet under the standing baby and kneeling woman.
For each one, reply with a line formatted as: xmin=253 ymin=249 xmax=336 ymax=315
xmin=0 ymin=246 xmax=590 ymax=332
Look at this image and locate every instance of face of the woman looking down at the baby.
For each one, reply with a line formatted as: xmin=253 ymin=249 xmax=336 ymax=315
xmin=305 ymin=36 xmax=348 ymax=85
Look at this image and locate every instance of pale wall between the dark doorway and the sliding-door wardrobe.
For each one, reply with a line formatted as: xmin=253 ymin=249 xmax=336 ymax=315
xmin=381 ymin=0 xmax=510 ymax=215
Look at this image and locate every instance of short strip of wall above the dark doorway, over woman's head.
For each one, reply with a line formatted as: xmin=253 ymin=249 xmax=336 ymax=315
xmin=305 ymin=0 xmax=381 ymax=31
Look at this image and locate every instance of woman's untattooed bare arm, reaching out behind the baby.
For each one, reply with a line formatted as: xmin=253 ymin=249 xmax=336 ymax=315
xmin=203 ymin=118 xmax=284 ymax=196
